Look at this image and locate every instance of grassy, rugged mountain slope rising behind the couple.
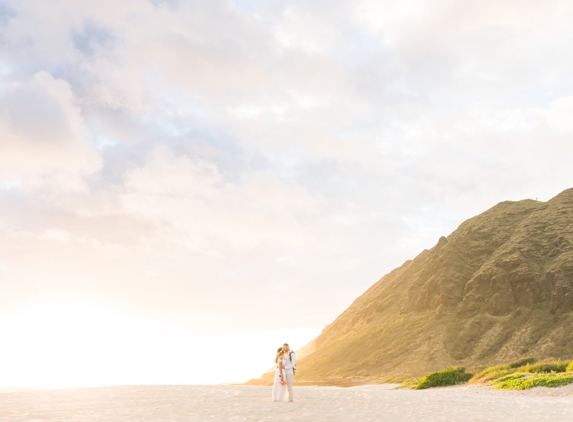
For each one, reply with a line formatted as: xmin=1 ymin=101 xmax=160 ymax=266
xmin=250 ymin=189 xmax=573 ymax=384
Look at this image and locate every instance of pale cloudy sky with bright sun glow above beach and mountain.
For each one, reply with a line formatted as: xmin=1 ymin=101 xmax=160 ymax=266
xmin=0 ymin=0 xmax=573 ymax=388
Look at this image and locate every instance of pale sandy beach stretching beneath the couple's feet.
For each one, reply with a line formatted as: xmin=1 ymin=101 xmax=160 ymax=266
xmin=0 ymin=385 xmax=573 ymax=422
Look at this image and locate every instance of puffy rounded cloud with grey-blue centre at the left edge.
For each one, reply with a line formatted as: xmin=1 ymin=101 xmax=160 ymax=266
xmin=0 ymin=72 xmax=101 ymax=190
